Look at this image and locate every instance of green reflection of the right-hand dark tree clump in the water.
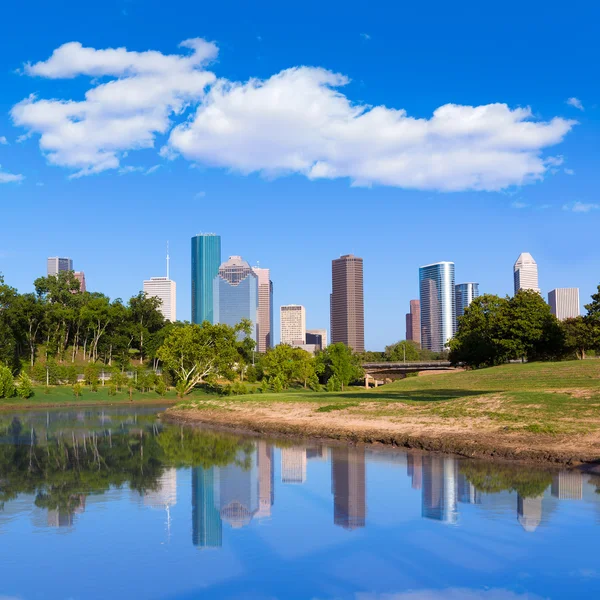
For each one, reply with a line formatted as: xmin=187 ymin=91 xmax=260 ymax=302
xmin=460 ymin=461 xmax=552 ymax=498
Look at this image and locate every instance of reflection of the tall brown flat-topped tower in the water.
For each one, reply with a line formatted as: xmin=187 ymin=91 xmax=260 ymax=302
xmin=331 ymin=447 xmax=366 ymax=529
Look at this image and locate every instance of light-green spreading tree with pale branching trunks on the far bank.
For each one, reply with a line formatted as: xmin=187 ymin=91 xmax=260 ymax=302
xmin=157 ymin=322 xmax=251 ymax=395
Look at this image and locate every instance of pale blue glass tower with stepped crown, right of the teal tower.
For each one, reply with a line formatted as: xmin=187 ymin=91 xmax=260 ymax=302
xmin=213 ymin=256 xmax=258 ymax=341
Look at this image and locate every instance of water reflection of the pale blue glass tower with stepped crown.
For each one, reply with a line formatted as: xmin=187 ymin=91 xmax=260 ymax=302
xmin=217 ymin=452 xmax=259 ymax=529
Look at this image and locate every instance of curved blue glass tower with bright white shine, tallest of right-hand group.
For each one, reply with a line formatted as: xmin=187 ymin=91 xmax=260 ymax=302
xmin=419 ymin=261 xmax=456 ymax=352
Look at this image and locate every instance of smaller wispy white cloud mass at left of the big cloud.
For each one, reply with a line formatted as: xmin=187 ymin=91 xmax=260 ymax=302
xmin=11 ymin=39 xmax=217 ymax=177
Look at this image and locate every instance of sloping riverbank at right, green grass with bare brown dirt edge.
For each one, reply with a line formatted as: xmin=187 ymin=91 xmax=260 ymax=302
xmin=163 ymin=360 xmax=600 ymax=464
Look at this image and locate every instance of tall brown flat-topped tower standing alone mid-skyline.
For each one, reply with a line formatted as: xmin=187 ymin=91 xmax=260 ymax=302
xmin=330 ymin=254 xmax=365 ymax=352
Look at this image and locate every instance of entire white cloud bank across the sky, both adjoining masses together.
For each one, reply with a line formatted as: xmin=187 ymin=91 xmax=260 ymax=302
xmin=12 ymin=39 xmax=575 ymax=191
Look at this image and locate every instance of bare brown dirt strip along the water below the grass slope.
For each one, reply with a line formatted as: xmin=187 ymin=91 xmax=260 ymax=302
xmin=160 ymin=403 xmax=600 ymax=468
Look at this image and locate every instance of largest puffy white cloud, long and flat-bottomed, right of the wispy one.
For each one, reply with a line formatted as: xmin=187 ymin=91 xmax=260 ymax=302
xmin=168 ymin=67 xmax=575 ymax=191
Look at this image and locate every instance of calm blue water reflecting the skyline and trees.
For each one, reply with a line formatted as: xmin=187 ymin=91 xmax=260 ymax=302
xmin=0 ymin=407 xmax=600 ymax=600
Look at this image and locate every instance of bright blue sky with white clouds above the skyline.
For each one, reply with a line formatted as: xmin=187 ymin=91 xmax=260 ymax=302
xmin=0 ymin=0 xmax=600 ymax=349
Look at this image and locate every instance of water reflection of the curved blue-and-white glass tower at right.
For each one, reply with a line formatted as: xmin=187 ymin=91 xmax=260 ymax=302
xmin=422 ymin=456 xmax=458 ymax=523
